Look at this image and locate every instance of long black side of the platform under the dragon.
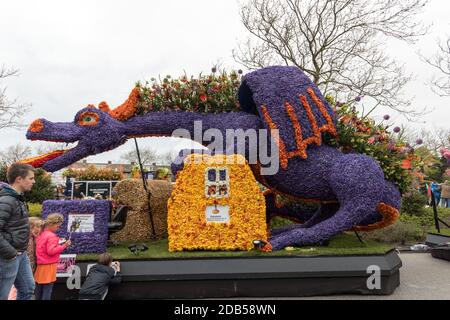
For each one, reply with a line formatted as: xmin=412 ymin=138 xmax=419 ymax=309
xmin=53 ymin=251 xmax=402 ymax=300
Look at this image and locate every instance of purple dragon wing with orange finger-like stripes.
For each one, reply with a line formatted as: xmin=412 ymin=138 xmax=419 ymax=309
xmin=238 ymin=66 xmax=337 ymax=169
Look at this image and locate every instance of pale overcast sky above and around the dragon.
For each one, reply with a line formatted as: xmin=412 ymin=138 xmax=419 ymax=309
xmin=0 ymin=0 xmax=450 ymax=162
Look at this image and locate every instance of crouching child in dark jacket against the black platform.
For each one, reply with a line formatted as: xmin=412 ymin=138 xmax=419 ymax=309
xmin=79 ymin=253 xmax=122 ymax=300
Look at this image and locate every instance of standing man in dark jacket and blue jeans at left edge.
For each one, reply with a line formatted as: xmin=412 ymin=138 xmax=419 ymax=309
xmin=0 ymin=163 xmax=35 ymax=300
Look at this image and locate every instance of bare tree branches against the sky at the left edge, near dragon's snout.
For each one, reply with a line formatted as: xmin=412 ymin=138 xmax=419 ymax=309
xmin=0 ymin=66 xmax=31 ymax=129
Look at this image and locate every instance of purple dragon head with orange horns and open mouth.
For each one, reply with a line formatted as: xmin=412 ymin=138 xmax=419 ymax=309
xmin=21 ymin=88 xmax=139 ymax=172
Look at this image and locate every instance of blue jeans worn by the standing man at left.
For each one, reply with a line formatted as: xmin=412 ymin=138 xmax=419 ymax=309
xmin=0 ymin=253 xmax=34 ymax=300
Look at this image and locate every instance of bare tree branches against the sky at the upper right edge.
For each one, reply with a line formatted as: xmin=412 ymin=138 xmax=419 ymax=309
xmin=422 ymin=36 xmax=450 ymax=97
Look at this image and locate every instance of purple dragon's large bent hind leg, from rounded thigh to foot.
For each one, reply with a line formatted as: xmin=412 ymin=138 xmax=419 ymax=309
xmin=270 ymin=154 xmax=386 ymax=250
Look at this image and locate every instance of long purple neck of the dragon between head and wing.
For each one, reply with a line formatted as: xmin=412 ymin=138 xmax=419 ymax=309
xmin=124 ymin=111 xmax=261 ymax=138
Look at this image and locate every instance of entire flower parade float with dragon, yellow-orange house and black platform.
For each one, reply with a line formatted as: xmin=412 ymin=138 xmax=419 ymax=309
xmin=20 ymin=66 xmax=408 ymax=298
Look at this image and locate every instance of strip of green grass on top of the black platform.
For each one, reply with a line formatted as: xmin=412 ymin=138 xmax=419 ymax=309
xmin=77 ymin=233 xmax=393 ymax=261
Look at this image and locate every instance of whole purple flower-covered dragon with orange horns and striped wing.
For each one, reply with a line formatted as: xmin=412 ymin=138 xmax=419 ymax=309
xmin=23 ymin=66 xmax=401 ymax=250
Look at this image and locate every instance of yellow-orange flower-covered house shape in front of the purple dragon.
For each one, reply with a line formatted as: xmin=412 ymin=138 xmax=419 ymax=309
xmin=168 ymin=154 xmax=267 ymax=252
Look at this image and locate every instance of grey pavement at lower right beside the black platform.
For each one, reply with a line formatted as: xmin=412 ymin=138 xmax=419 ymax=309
xmin=302 ymin=253 xmax=450 ymax=300
